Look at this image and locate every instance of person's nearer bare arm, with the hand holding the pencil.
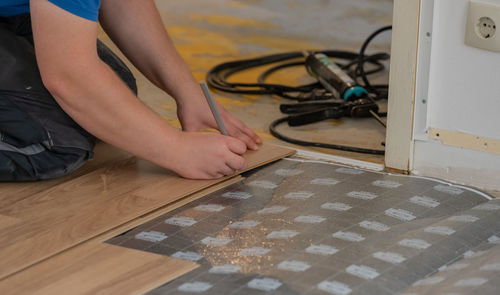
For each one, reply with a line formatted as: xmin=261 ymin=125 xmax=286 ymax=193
xmin=31 ymin=0 xmax=245 ymax=178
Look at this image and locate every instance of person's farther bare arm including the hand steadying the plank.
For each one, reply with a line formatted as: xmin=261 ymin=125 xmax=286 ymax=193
xmin=100 ymin=0 xmax=261 ymax=149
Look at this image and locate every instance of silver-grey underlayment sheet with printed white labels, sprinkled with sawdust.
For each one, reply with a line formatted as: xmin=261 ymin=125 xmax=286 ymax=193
xmin=108 ymin=158 xmax=500 ymax=295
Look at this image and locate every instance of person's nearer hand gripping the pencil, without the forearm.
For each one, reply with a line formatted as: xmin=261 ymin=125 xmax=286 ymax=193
xmin=166 ymin=132 xmax=247 ymax=179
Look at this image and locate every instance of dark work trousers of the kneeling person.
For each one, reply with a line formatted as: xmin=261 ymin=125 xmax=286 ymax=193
xmin=0 ymin=14 xmax=137 ymax=181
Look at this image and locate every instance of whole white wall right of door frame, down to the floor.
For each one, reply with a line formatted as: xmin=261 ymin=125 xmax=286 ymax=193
xmin=411 ymin=0 xmax=500 ymax=190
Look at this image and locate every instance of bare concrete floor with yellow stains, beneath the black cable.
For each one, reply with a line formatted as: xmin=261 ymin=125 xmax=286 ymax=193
xmin=100 ymin=0 xmax=393 ymax=163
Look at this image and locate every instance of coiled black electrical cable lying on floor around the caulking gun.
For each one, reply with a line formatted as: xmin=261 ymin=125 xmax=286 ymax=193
xmin=206 ymin=26 xmax=392 ymax=155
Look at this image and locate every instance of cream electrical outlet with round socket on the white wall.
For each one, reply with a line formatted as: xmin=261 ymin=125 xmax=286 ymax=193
xmin=465 ymin=1 xmax=500 ymax=52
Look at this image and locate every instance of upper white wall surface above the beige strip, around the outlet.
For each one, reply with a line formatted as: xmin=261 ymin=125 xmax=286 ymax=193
xmin=427 ymin=0 xmax=500 ymax=139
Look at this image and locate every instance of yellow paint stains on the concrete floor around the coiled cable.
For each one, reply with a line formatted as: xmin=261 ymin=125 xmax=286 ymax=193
xmin=165 ymin=19 xmax=322 ymax=114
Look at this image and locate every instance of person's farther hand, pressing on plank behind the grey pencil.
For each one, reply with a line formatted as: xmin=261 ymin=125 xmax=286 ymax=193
xmin=177 ymin=94 xmax=262 ymax=150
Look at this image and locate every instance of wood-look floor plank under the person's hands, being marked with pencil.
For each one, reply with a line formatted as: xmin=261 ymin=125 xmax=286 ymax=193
xmin=0 ymin=145 xmax=293 ymax=278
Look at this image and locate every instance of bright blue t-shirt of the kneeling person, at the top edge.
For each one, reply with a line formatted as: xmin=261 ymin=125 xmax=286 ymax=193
xmin=0 ymin=0 xmax=101 ymax=21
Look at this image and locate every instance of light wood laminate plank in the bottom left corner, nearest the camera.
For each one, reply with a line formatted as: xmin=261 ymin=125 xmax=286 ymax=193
xmin=0 ymin=242 xmax=198 ymax=295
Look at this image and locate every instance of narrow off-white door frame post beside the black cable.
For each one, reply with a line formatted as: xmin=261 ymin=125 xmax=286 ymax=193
xmin=385 ymin=0 xmax=420 ymax=173
